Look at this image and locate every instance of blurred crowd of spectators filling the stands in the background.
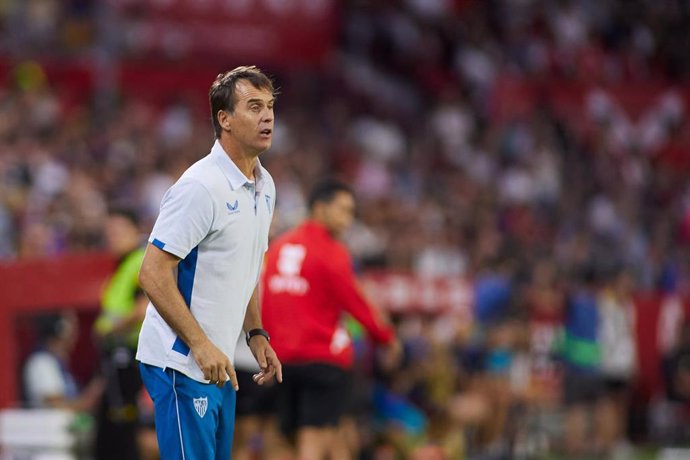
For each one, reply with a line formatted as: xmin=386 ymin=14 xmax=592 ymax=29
xmin=0 ymin=0 xmax=690 ymax=459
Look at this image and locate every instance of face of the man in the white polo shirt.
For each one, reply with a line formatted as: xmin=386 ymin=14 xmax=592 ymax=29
xmin=223 ymin=80 xmax=275 ymax=156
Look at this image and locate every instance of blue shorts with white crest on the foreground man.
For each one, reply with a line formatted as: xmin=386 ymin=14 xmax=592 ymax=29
xmin=139 ymin=363 xmax=236 ymax=460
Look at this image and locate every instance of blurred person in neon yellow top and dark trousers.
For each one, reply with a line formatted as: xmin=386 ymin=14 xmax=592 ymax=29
xmin=94 ymin=208 xmax=153 ymax=460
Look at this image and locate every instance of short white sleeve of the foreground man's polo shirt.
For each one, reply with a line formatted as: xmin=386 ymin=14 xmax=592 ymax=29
xmin=149 ymin=179 xmax=214 ymax=259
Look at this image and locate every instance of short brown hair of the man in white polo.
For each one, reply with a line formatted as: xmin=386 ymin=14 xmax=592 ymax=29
xmin=208 ymin=65 xmax=277 ymax=139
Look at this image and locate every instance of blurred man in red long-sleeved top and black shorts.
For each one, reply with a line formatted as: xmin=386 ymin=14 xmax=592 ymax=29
xmin=262 ymin=181 xmax=399 ymax=460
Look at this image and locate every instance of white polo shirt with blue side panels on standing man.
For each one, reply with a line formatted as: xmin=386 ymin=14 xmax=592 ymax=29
xmin=137 ymin=141 xmax=276 ymax=382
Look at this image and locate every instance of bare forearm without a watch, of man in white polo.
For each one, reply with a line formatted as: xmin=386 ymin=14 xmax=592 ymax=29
xmin=139 ymin=244 xmax=239 ymax=390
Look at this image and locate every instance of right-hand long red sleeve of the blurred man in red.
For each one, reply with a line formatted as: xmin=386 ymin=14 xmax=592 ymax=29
xmin=328 ymin=250 xmax=395 ymax=343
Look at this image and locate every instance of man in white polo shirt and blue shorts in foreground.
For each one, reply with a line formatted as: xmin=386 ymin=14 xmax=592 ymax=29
xmin=137 ymin=66 xmax=282 ymax=460
